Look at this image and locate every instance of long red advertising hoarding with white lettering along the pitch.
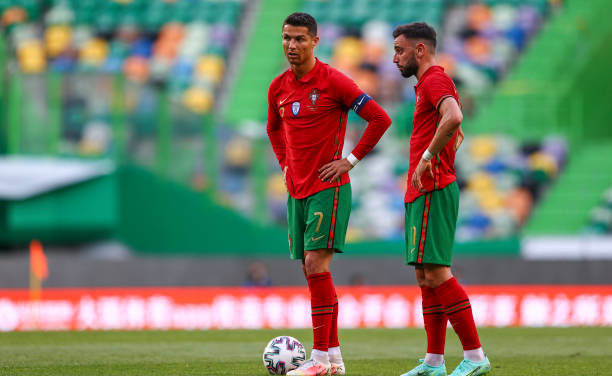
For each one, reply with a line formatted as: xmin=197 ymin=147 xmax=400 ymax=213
xmin=0 ymin=285 xmax=612 ymax=331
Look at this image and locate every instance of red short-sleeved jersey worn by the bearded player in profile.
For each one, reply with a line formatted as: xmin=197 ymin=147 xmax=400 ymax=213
xmin=404 ymin=65 xmax=460 ymax=202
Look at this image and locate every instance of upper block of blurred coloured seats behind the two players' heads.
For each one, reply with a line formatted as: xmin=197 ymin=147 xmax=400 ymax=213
xmin=304 ymin=0 xmax=553 ymax=113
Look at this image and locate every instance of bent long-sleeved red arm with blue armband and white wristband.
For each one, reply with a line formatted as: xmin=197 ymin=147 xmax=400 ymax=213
xmin=319 ymin=98 xmax=391 ymax=181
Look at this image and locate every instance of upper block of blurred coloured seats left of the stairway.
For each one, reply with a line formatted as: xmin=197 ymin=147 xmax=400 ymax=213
xmin=0 ymin=0 xmax=243 ymax=113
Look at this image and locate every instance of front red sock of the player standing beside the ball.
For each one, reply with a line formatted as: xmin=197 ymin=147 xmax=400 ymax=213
xmin=307 ymin=272 xmax=334 ymax=351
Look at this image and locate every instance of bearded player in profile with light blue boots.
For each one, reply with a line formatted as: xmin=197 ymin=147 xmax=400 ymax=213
xmin=393 ymin=23 xmax=491 ymax=376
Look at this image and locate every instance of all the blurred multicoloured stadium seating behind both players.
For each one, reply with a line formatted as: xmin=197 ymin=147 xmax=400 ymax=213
xmin=0 ymin=0 xmax=612 ymax=251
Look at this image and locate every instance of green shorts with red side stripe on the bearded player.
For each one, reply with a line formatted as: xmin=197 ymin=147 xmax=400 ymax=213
xmin=406 ymin=182 xmax=459 ymax=266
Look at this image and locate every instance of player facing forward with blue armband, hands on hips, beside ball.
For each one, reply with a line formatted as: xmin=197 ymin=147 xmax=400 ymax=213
xmin=267 ymin=13 xmax=391 ymax=376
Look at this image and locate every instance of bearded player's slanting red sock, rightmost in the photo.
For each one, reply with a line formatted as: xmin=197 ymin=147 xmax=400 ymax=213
xmin=435 ymin=277 xmax=481 ymax=350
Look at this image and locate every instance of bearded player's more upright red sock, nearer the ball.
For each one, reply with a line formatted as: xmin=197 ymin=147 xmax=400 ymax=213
xmin=421 ymin=287 xmax=447 ymax=354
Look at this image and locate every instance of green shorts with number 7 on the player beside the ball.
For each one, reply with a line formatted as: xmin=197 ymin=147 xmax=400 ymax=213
xmin=287 ymin=183 xmax=351 ymax=260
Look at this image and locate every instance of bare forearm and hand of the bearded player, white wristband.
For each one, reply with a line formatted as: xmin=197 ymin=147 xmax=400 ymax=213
xmin=411 ymin=96 xmax=463 ymax=192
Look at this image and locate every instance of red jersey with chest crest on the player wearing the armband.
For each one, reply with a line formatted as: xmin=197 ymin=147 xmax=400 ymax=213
xmin=268 ymin=59 xmax=370 ymax=199
